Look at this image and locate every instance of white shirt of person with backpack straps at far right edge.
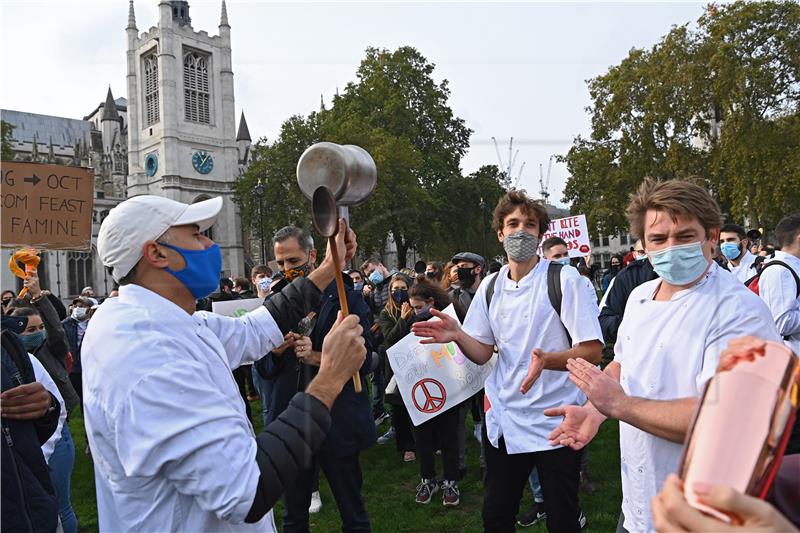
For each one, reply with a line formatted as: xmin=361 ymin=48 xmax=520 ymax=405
xmin=758 ymin=251 xmax=800 ymax=356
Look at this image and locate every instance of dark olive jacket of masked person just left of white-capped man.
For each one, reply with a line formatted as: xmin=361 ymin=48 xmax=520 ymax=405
xmin=33 ymin=298 xmax=81 ymax=411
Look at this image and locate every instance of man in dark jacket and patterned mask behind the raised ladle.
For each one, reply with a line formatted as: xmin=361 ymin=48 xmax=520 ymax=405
xmin=256 ymin=226 xmax=375 ymax=533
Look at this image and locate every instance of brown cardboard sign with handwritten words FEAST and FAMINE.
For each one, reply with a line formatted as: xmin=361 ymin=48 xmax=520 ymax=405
xmin=1 ymin=161 xmax=94 ymax=250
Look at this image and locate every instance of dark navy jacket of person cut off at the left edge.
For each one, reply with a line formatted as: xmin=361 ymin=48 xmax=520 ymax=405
xmin=0 ymin=317 xmax=60 ymax=532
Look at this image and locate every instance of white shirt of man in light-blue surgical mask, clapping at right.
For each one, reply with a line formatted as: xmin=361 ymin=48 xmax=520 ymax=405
xmin=614 ymin=263 xmax=779 ymax=533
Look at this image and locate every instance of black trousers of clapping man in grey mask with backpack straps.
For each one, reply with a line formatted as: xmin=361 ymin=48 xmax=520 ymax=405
xmin=482 ymin=425 xmax=580 ymax=533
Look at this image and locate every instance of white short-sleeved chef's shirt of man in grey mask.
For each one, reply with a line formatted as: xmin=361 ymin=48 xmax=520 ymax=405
xmin=464 ymin=259 xmax=603 ymax=454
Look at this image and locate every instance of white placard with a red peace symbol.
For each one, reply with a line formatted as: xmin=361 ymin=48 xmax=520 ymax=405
xmin=386 ymin=305 xmax=497 ymax=426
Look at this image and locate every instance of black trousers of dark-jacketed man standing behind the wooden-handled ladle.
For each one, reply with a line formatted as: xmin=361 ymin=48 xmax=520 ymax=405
xmin=283 ymin=445 xmax=371 ymax=533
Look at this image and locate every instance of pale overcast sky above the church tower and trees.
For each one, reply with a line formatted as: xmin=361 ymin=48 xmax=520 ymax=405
xmin=0 ymin=0 xmax=704 ymax=204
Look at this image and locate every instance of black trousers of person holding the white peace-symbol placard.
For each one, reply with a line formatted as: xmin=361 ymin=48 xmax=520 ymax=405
xmin=414 ymin=406 xmax=456 ymax=481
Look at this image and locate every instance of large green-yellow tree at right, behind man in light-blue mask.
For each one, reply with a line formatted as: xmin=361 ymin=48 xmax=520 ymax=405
xmin=561 ymin=2 xmax=800 ymax=233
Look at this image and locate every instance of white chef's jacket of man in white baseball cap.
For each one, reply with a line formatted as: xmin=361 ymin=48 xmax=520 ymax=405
xmin=81 ymin=285 xmax=283 ymax=532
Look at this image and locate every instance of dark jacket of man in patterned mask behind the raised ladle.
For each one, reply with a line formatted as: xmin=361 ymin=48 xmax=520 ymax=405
xmin=255 ymin=283 xmax=376 ymax=456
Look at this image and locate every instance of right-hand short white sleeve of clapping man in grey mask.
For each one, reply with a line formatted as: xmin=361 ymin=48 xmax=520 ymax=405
xmin=561 ymin=267 xmax=603 ymax=346
